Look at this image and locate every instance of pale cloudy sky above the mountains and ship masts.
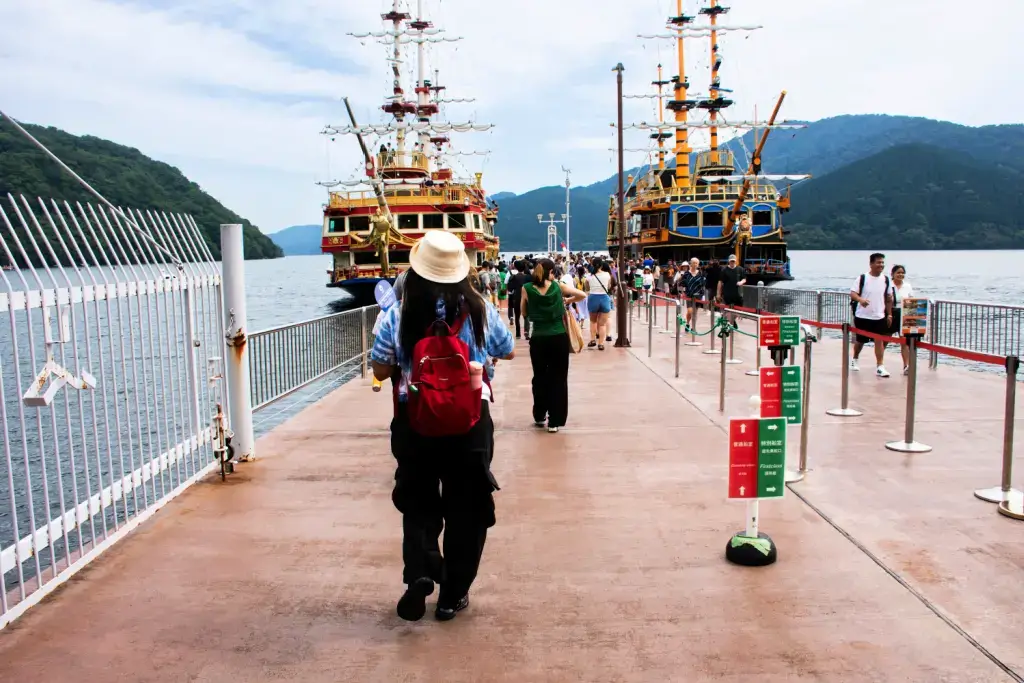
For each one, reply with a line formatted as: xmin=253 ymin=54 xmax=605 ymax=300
xmin=0 ymin=0 xmax=1024 ymax=232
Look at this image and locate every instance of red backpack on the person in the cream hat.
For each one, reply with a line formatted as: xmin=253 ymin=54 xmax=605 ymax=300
xmin=409 ymin=314 xmax=481 ymax=436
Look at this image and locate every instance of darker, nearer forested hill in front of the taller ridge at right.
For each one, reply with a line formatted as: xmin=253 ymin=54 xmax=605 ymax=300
xmin=787 ymin=144 xmax=1024 ymax=249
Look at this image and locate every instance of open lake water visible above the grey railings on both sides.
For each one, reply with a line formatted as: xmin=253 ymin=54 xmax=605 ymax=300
xmin=246 ymin=251 xmax=1024 ymax=330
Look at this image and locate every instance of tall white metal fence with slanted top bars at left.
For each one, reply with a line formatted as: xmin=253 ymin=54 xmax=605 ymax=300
xmin=0 ymin=195 xmax=225 ymax=628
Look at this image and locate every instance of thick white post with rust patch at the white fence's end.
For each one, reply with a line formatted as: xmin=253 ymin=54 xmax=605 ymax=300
xmin=220 ymin=224 xmax=256 ymax=461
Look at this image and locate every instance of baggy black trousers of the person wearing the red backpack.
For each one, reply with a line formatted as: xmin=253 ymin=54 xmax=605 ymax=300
xmin=391 ymin=402 xmax=498 ymax=605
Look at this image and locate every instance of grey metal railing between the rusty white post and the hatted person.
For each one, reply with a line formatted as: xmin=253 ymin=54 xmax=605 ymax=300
xmin=249 ymin=305 xmax=380 ymax=411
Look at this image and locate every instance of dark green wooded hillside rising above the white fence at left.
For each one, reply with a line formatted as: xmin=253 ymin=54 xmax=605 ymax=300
xmin=0 ymin=120 xmax=283 ymax=258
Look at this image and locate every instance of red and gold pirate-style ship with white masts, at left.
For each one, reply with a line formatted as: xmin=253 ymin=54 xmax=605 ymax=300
xmin=321 ymin=0 xmax=499 ymax=302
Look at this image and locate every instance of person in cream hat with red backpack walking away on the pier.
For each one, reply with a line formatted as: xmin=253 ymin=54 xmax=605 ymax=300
xmin=370 ymin=230 xmax=515 ymax=621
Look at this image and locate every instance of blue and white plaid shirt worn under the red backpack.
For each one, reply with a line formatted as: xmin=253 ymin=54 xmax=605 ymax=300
xmin=370 ymin=303 xmax=515 ymax=402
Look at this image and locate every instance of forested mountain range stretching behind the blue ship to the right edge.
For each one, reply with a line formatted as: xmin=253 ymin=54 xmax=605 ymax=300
xmin=489 ymin=115 xmax=1024 ymax=251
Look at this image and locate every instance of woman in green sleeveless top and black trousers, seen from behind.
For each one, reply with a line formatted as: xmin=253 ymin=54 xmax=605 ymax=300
xmin=520 ymin=258 xmax=587 ymax=433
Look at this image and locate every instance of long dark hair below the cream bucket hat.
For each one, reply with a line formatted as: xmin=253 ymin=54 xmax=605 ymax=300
xmin=398 ymin=268 xmax=487 ymax=357
